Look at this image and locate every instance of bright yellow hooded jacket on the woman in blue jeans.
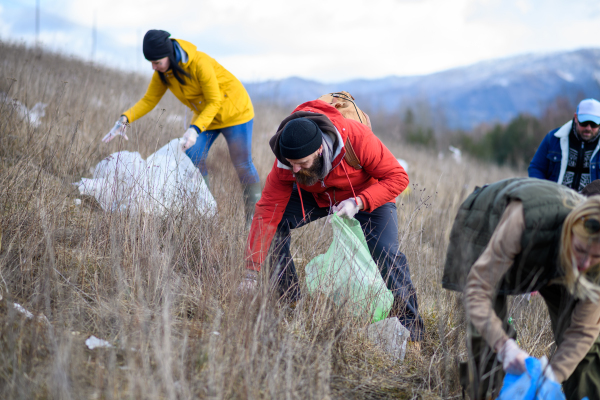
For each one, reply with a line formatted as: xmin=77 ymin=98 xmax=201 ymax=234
xmin=123 ymin=39 xmax=254 ymax=132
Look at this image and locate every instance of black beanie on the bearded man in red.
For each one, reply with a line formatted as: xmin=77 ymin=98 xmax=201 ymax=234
xmin=279 ymin=118 xmax=323 ymax=160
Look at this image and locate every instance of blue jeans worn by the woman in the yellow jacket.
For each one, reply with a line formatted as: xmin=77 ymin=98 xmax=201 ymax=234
xmin=185 ymin=119 xmax=259 ymax=185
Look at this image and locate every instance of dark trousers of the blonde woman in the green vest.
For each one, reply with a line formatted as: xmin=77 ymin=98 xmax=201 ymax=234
xmin=468 ymin=285 xmax=600 ymax=400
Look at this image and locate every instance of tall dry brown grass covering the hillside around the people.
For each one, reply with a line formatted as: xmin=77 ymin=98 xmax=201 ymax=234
xmin=0 ymin=43 xmax=552 ymax=399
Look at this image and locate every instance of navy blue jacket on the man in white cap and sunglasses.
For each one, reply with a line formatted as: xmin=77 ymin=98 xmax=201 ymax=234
xmin=528 ymin=121 xmax=600 ymax=183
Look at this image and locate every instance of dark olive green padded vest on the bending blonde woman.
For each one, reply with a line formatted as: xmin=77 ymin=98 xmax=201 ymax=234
xmin=442 ymin=178 xmax=583 ymax=294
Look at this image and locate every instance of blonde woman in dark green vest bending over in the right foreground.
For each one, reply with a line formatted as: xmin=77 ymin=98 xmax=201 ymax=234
xmin=442 ymin=178 xmax=600 ymax=400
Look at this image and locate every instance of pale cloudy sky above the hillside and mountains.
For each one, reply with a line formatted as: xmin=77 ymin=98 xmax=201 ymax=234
xmin=0 ymin=0 xmax=600 ymax=82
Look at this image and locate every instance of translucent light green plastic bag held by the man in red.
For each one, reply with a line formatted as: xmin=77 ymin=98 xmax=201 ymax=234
xmin=305 ymin=214 xmax=394 ymax=322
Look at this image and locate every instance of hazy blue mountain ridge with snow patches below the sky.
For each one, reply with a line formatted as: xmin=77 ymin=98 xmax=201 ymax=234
xmin=245 ymin=49 xmax=600 ymax=129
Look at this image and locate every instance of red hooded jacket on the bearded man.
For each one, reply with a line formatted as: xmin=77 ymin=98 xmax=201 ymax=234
xmin=246 ymin=100 xmax=408 ymax=271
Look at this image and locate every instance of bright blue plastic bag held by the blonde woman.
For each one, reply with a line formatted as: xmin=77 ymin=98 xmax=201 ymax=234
xmin=498 ymin=357 xmax=565 ymax=400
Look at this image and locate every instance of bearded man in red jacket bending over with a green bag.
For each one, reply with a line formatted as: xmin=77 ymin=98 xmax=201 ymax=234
xmin=242 ymin=100 xmax=423 ymax=341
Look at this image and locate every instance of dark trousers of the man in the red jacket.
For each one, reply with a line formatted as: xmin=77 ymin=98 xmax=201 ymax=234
xmin=271 ymin=186 xmax=423 ymax=341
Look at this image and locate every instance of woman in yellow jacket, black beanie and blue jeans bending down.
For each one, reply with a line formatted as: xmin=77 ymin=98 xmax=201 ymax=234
xmin=103 ymin=29 xmax=261 ymax=224
